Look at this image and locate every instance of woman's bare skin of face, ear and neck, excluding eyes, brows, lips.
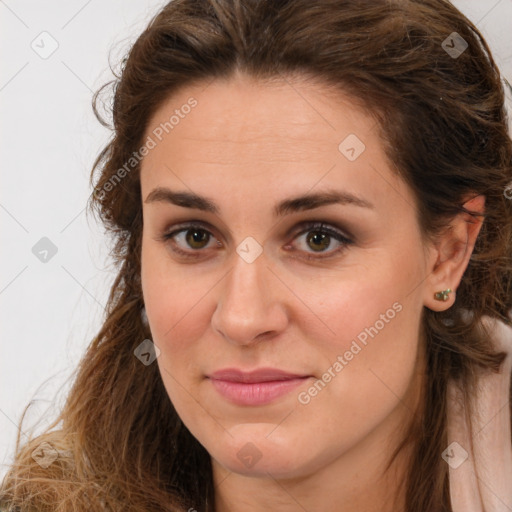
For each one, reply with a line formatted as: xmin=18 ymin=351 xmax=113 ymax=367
xmin=141 ymin=70 xmax=484 ymax=512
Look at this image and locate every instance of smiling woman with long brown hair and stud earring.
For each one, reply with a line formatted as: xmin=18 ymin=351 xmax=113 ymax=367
xmin=2 ymin=0 xmax=512 ymax=512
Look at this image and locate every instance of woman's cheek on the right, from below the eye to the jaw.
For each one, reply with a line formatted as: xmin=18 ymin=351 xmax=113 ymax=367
xmin=299 ymin=249 xmax=423 ymax=420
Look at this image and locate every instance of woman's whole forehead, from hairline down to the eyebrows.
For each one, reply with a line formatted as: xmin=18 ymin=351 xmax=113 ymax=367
xmin=141 ymin=76 xmax=407 ymax=216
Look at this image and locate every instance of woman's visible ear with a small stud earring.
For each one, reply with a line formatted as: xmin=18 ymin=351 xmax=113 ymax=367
xmin=424 ymin=195 xmax=485 ymax=311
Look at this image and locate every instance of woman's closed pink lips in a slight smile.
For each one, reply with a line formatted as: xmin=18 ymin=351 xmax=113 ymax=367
xmin=209 ymin=368 xmax=311 ymax=405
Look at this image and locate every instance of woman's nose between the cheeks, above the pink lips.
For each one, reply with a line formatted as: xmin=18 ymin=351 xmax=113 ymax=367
xmin=212 ymin=249 xmax=290 ymax=345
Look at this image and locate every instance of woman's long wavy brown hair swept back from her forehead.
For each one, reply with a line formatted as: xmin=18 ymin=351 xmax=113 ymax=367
xmin=0 ymin=0 xmax=512 ymax=512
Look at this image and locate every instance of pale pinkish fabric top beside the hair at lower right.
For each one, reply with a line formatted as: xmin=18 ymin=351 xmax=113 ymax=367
xmin=448 ymin=317 xmax=512 ymax=512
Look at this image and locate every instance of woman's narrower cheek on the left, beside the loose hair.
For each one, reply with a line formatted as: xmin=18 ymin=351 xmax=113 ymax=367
xmin=141 ymin=241 xmax=228 ymax=418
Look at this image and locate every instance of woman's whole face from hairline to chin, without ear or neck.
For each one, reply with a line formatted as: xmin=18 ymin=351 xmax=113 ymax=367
xmin=141 ymin=76 xmax=430 ymax=478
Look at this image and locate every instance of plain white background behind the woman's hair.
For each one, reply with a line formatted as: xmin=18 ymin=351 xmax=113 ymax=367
xmin=0 ymin=0 xmax=512 ymax=477
